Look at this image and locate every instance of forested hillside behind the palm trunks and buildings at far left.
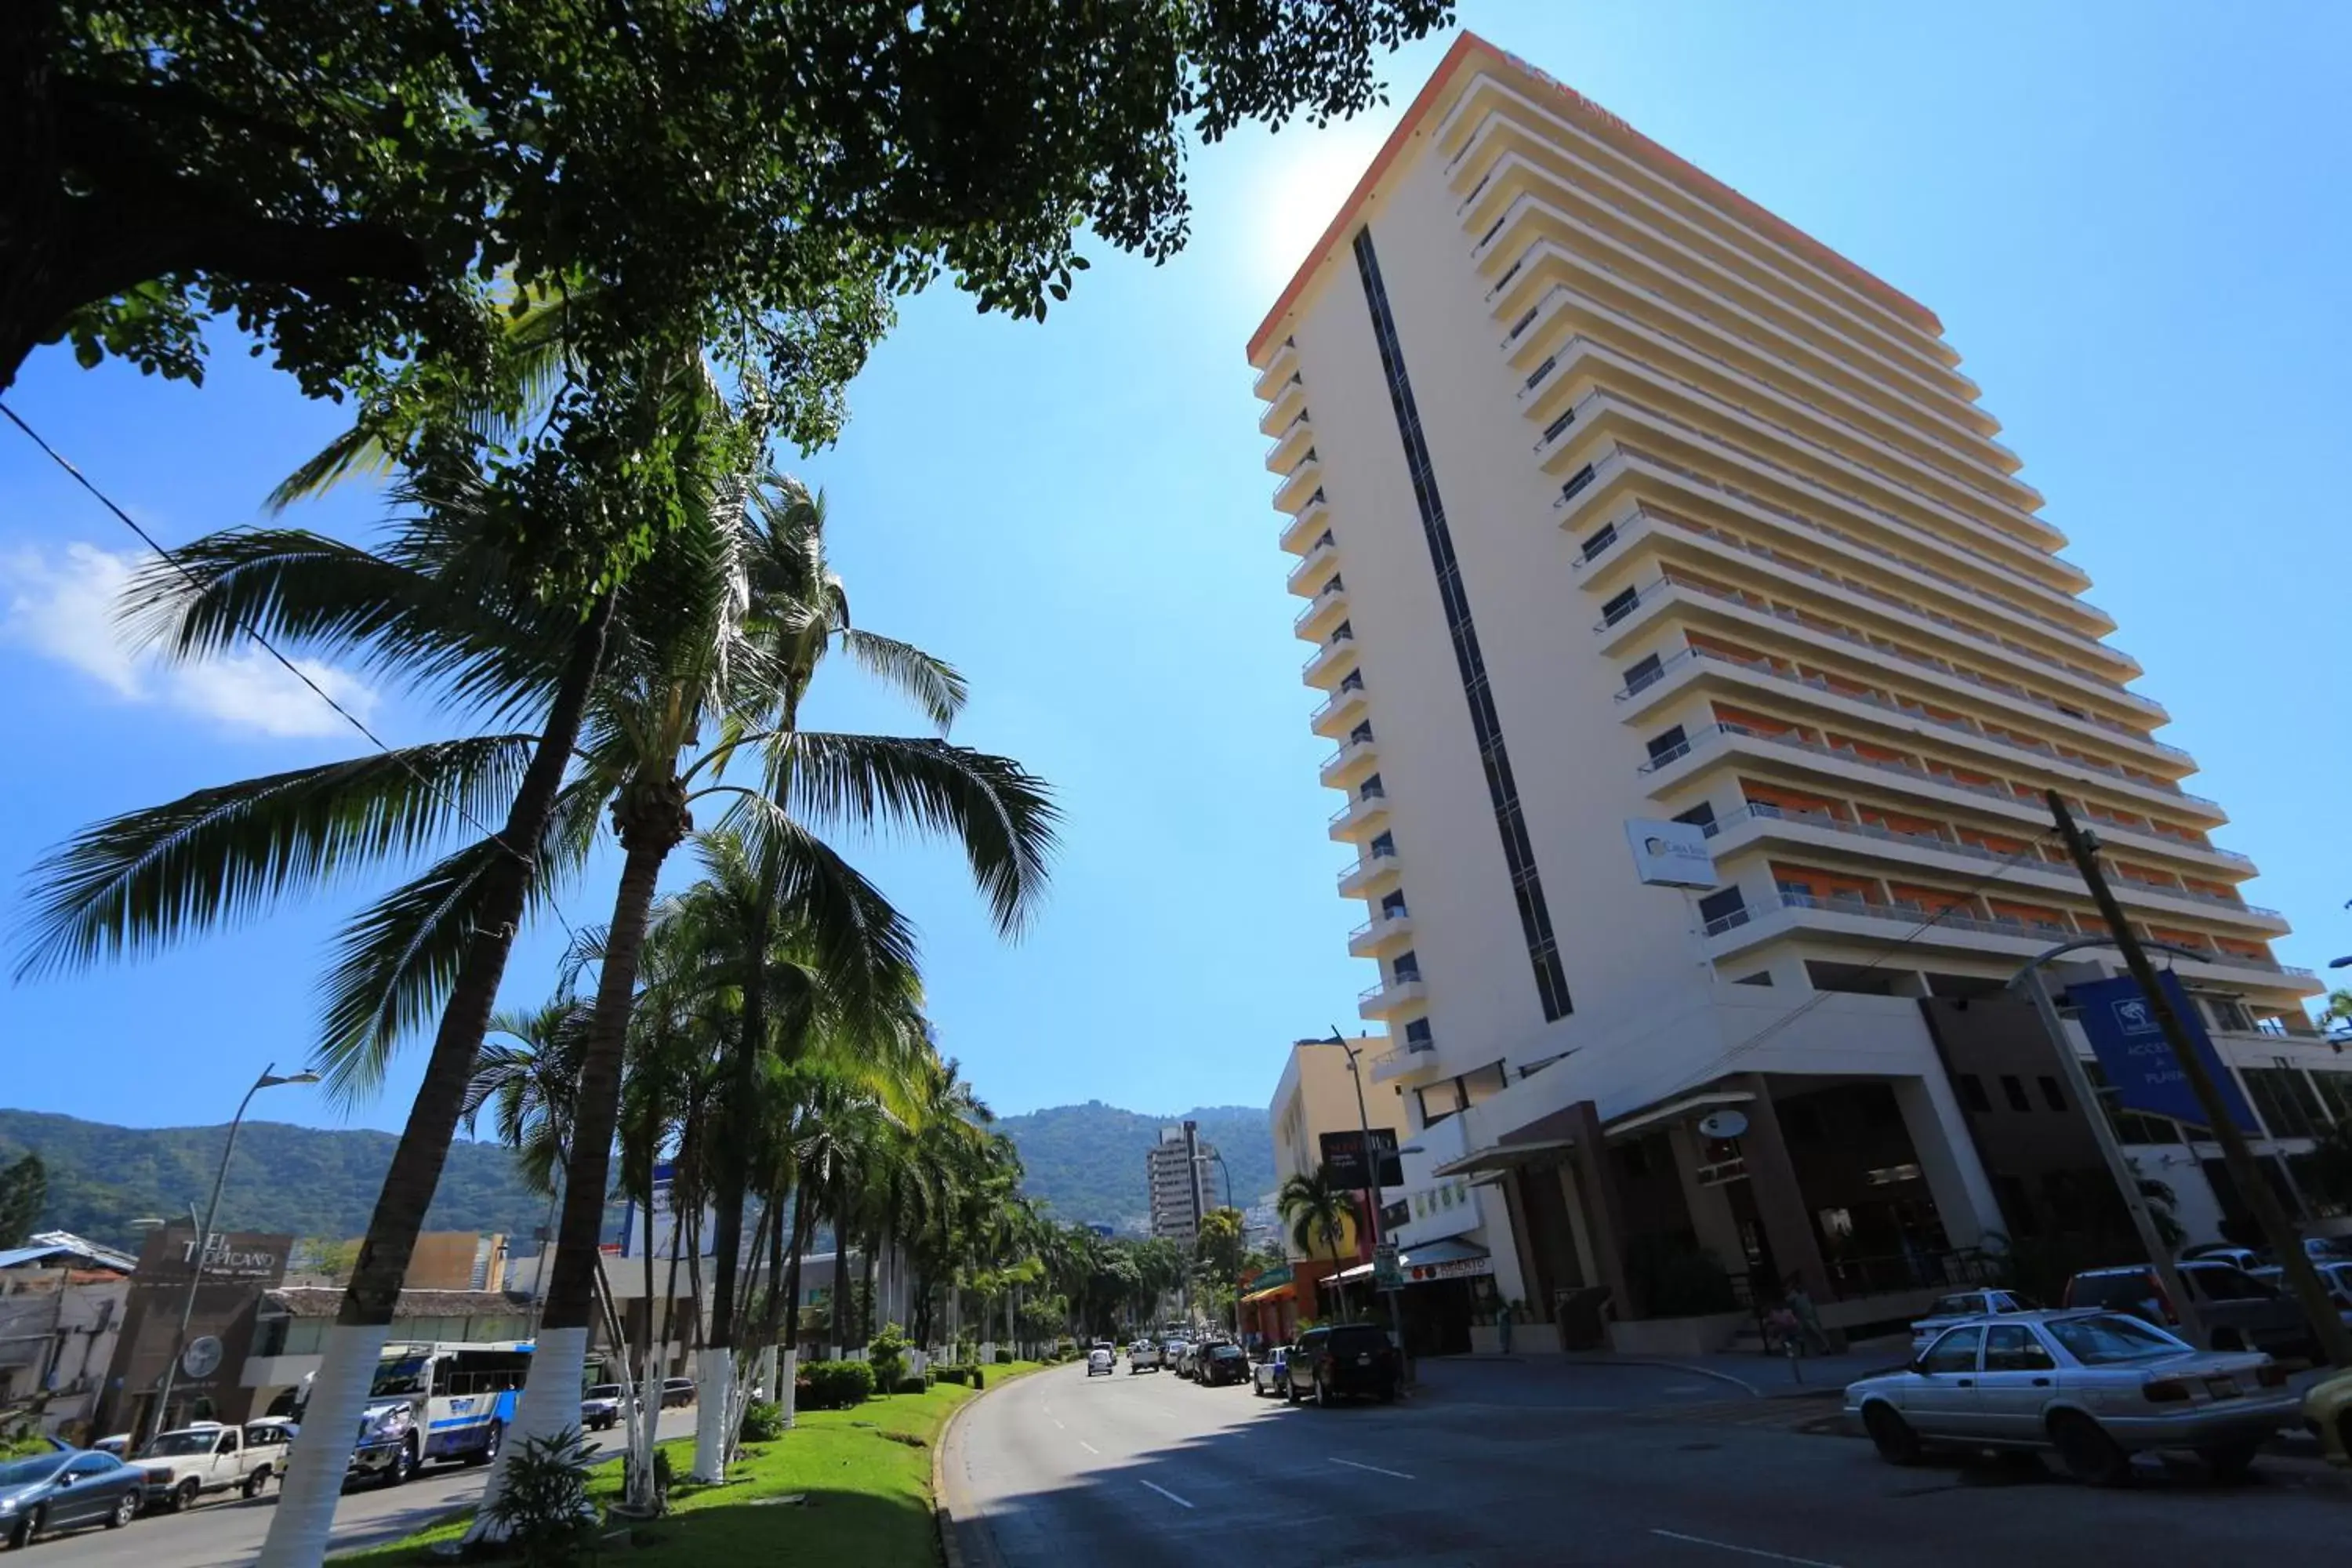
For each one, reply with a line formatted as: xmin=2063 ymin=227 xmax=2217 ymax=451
xmin=0 ymin=1109 xmax=548 ymax=1250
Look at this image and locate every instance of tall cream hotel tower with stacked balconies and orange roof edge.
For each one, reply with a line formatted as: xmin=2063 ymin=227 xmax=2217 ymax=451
xmin=1249 ymin=35 xmax=2352 ymax=1345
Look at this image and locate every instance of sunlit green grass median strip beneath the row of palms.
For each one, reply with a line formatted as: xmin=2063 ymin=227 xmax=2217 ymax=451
xmin=329 ymin=1361 xmax=1042 ymax=1568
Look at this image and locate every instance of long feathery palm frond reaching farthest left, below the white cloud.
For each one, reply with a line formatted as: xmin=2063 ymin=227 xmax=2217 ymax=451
xmin=16 ymin=736 xmax=534 ymax=978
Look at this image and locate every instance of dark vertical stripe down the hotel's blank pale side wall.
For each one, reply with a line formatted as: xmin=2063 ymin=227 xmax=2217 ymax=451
xmin=1355 ymin=228 xmax=1571 ymax=1022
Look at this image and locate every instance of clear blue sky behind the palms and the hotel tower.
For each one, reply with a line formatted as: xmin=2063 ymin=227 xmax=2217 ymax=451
xmin=0 ymin=0 xmax=2352 ymax=1126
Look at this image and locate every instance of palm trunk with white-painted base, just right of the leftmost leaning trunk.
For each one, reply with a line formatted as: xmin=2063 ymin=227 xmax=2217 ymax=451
xmin=477 ymin=779 xmax=689 ymax=1533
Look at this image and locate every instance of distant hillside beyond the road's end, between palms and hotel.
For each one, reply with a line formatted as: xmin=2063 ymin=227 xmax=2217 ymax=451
xmin=997 ymin=1100 xmax=1275 ymax=1227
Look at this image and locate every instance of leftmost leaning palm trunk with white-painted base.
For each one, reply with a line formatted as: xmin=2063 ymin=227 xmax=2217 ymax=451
xmin=259 ymin=593 xmax=614 ymax=1568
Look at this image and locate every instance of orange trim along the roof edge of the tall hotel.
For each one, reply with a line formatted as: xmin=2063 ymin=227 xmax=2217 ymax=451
xmin=1249 ymin=33 xmax=1943 ymax=362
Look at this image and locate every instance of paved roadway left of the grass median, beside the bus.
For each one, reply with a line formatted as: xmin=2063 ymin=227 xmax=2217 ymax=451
xmin=26 ymin=1410 xmax=694 ymax=1568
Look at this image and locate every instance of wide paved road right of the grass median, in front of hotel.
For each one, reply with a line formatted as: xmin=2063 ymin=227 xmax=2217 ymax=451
xmin=943 ymin=1366 xmax=2352 ymax=1568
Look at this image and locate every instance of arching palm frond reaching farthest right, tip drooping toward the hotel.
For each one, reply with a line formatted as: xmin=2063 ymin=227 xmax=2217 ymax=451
xmin=769 ymin=731 xmax=1061 ymax=935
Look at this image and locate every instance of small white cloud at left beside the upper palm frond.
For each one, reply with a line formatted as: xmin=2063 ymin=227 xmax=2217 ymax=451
xmin=0 ymin=543 xmax=376 ymax=736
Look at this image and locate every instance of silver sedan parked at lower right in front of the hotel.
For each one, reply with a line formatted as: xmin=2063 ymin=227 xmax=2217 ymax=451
xmin=1846 ymin=1312 xmax=2298 ymax=1486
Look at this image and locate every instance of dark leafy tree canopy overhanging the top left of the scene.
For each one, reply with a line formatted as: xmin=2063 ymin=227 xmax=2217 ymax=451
xmin=0 ymin=0 xmax=1449 ymax=583
